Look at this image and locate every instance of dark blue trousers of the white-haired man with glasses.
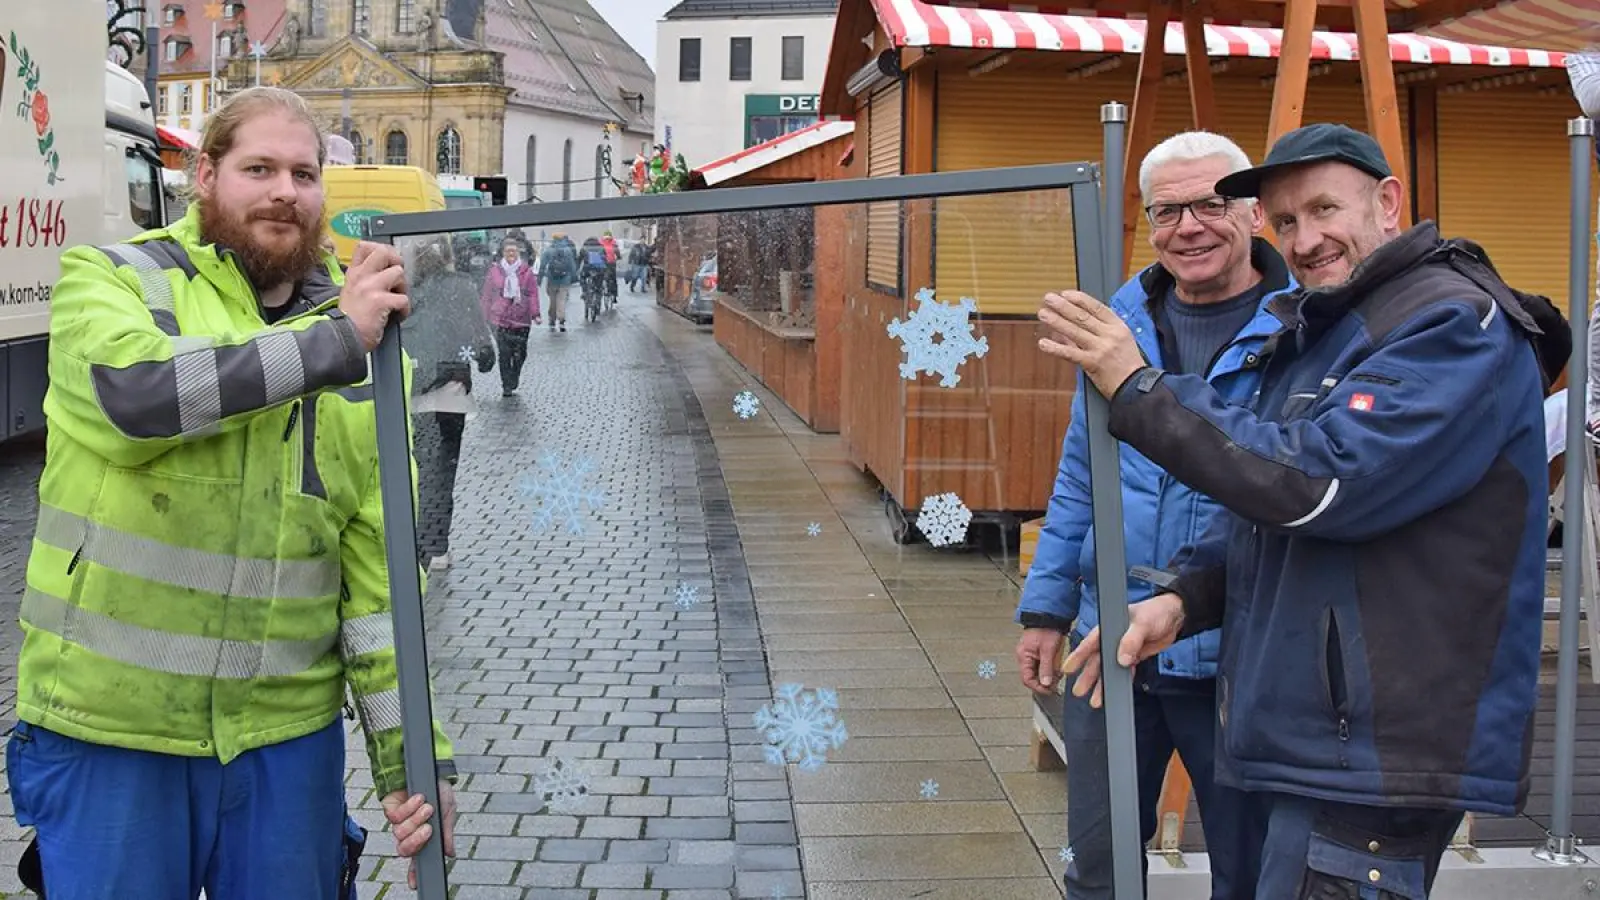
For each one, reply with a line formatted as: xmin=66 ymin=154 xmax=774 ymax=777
xmin=1062 ymin=656 xmax=1267 ymax=900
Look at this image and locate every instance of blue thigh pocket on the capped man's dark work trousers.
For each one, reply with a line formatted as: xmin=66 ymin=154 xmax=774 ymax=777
xmin=1294 ymin=818 xmax=1430 ymax=900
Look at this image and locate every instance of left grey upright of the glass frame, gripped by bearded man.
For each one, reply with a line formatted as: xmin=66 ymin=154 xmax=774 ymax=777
xmin=373 ymin=229 xmax=448 ymax=900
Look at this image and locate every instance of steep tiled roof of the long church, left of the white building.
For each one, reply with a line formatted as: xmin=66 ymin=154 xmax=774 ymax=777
xmin=480 ymin=0 xmax=656 ymax=133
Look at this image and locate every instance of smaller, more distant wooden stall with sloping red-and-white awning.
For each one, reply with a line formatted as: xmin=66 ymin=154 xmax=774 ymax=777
xmin=690 ymin=122 xmax=856 ymax=432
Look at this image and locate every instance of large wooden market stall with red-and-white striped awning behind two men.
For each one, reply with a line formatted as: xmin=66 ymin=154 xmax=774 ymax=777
xmin=821 ymin=0 xmax=1587 ymax=525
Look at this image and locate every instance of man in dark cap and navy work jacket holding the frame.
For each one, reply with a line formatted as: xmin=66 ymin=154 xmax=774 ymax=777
xmin=1040 ymin=125 xmax=1570 ymax=900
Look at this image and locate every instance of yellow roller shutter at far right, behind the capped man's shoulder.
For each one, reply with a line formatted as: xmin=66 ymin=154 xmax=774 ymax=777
xmin=1438 ymin=88 xmax=1600 ymax=309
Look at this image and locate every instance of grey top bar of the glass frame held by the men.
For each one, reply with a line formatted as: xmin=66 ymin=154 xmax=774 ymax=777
xmin=368 ymin=162 xmax=1096 ymax=239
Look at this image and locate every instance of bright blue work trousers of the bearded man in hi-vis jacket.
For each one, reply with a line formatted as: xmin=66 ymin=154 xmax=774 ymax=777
xmin=6 ymin=721 xmax=358 ymax=900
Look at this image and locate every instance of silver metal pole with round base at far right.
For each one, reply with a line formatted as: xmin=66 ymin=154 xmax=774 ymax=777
xmin=1530 ymin=112 xmax=1595 ymax=865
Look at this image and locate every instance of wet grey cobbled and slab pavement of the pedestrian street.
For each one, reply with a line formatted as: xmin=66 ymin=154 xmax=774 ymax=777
xmin=0 ymin=291 xmax=1066 ymax=900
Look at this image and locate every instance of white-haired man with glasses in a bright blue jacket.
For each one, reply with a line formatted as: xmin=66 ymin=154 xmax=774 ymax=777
xmin=1016 ymin=131 xmax=1293 ymax=900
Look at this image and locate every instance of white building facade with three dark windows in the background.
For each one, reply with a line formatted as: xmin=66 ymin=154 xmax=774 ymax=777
xmin=656 ymin=16 xmax=834 ymax=168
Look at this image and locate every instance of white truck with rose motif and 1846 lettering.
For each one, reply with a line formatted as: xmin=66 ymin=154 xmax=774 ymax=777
xmin=0 ymin=0 xmax=166 ymax=440
